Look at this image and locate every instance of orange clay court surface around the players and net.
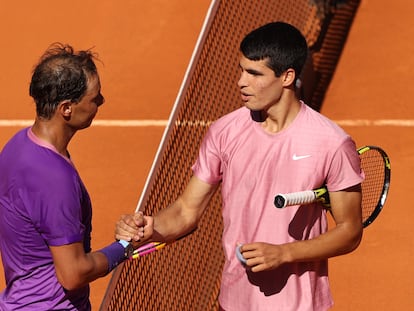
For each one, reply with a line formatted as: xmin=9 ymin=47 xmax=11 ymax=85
xmin=0 ymin=0 xmax=414 ymax=311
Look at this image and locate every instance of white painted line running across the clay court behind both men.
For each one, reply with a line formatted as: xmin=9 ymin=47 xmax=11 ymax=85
xmin=0 ymin=119 xmax=414 ymax=127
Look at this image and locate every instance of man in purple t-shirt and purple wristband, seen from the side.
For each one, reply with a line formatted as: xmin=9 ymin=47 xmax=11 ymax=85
xmin=0 ymin=43 xmax=144 ymax=311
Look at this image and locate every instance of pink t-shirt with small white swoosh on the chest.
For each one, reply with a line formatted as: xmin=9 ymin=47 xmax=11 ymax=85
xmin=193 ymin=103 xmax=363 ymax=311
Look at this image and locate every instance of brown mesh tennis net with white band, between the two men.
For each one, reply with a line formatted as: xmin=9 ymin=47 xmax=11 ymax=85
xmin=100 ymin=0 xmax=359 ymax=311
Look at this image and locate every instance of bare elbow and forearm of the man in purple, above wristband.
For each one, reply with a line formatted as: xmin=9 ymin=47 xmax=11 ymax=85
xmin=50 ymin=242 xmax=108 ymax=290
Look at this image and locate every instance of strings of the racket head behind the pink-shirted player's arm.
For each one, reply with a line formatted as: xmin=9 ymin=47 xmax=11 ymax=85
xmin=360 ymin=149 xmax=385 ymax=222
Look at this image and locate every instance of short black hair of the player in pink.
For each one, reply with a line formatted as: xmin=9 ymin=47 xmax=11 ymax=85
xmin=240 ymin=22 xmax=308 ymax=78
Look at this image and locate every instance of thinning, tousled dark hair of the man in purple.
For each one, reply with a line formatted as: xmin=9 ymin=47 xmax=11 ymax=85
xmin=29 ymin=42 xmax=98 ymax=119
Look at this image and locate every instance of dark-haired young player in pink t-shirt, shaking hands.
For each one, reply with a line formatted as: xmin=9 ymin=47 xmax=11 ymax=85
xmin=116 ymin=22 xmax=364 ymax=311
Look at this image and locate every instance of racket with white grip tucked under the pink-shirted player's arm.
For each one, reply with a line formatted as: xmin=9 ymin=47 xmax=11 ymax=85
xmin=274 ymin=146 xmax=391 ymax=228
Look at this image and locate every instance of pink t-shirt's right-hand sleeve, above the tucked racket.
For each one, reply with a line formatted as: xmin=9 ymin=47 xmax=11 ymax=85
xmin=326 ymin=137 xmax=364 ymax=191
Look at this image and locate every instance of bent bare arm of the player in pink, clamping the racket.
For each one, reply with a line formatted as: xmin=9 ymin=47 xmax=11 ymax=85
xmin=241 ymin=187 xmax=363 ymax=272
